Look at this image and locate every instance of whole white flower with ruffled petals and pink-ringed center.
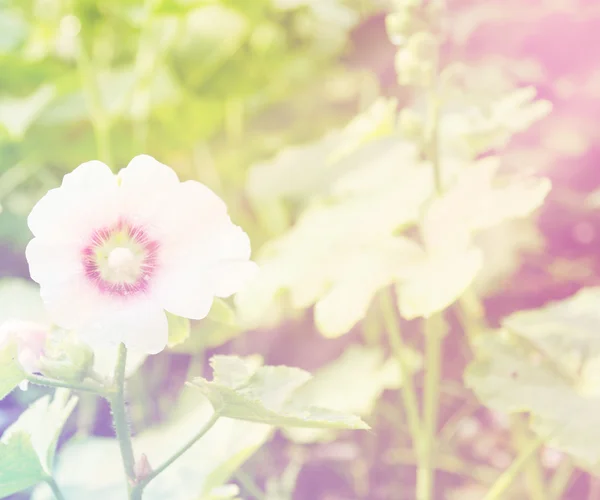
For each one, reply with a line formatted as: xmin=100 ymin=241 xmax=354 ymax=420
xmin=27 ymin=155 xmax=255 ymax=354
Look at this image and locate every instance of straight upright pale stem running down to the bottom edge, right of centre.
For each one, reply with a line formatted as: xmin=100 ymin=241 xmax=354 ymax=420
xmin=416 ymin=314 xmax=444 ymax=500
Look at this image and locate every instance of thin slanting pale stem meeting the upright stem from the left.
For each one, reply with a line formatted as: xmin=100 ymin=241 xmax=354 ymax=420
xmin=381 ymin=290 xmax=421 ymax=449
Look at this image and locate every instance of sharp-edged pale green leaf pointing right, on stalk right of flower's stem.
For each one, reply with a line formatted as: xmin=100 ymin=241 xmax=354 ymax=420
xmin=191 ymin=356 xmax=369 ymax=429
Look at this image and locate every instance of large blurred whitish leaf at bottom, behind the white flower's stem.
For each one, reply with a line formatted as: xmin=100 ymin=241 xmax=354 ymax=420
xmin=32 ymin=388 xmax=271 ymax=500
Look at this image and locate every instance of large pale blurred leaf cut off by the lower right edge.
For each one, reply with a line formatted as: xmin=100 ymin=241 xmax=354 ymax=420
xmin=465 ymin=287 xmax=600 ymax=469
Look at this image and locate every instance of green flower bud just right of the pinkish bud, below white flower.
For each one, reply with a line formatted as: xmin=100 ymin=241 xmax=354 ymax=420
xmin=40 ymin=330 xmax=94 ymax=382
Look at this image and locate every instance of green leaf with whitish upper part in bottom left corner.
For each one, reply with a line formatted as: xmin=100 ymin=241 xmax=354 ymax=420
xmin=0 ymin=390 xmax=77 ymax=497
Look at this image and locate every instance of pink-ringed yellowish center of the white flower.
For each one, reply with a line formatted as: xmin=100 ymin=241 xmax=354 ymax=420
xmin=82 ymin=220 xmax=159 ymax=296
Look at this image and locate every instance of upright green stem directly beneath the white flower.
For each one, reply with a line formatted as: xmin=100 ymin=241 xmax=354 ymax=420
xmin=108 ymin=343 xmax=136 ymax=488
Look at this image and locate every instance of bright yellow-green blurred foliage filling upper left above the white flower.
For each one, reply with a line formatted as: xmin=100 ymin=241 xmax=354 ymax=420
xmin=0 ymin=0 xmax=376 ymax=249
